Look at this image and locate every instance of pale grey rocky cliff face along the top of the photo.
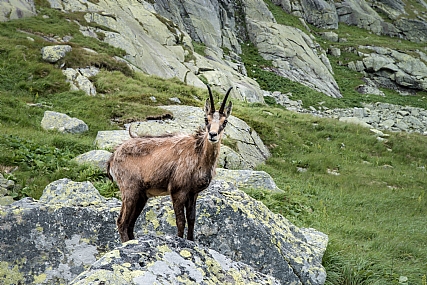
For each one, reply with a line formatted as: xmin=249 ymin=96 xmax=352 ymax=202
xmin=0 ymin=0 xmax=427 ymax=97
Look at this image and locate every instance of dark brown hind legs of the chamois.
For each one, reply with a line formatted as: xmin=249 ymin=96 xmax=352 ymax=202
xmin=117 ymin=187 xmax=148 ymax=242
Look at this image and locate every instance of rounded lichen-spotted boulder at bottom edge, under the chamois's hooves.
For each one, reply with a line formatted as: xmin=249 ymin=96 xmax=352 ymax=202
xmin=73 ymin=234 xmax=281 ymax=285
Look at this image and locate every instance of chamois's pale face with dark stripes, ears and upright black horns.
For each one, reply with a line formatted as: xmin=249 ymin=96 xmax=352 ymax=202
xmin=205 ymin=85 xmax=233 ymax=143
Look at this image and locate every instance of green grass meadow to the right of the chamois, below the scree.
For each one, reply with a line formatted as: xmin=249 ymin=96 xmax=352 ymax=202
xmin=235 ymin=103 xmax=427 ymax=284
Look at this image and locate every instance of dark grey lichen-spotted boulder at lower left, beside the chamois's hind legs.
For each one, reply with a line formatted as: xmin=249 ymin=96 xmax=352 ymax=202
xmin=0 ymin=179 xmax=120 ymax=284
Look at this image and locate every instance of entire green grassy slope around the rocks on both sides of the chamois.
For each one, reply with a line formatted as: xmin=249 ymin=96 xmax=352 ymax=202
xmin=0 ymin=2 xmax=427 ymax=284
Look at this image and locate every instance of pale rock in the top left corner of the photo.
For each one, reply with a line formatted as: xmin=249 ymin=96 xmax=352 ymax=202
xmin=0 ymin=0 xmax=37 ymax=22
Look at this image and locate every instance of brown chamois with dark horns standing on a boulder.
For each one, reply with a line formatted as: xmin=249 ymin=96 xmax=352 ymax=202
xmin=107 ymin=85 xmax=232 ymax=242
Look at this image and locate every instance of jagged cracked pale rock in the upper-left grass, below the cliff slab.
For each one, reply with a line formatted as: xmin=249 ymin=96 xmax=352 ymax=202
xmin=62 ymin=67 xmax=99 ymax=96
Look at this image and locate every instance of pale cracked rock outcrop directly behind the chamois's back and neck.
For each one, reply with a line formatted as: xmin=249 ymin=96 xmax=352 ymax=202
xmin=95 ymin=105 xmax=270 ymax=169
